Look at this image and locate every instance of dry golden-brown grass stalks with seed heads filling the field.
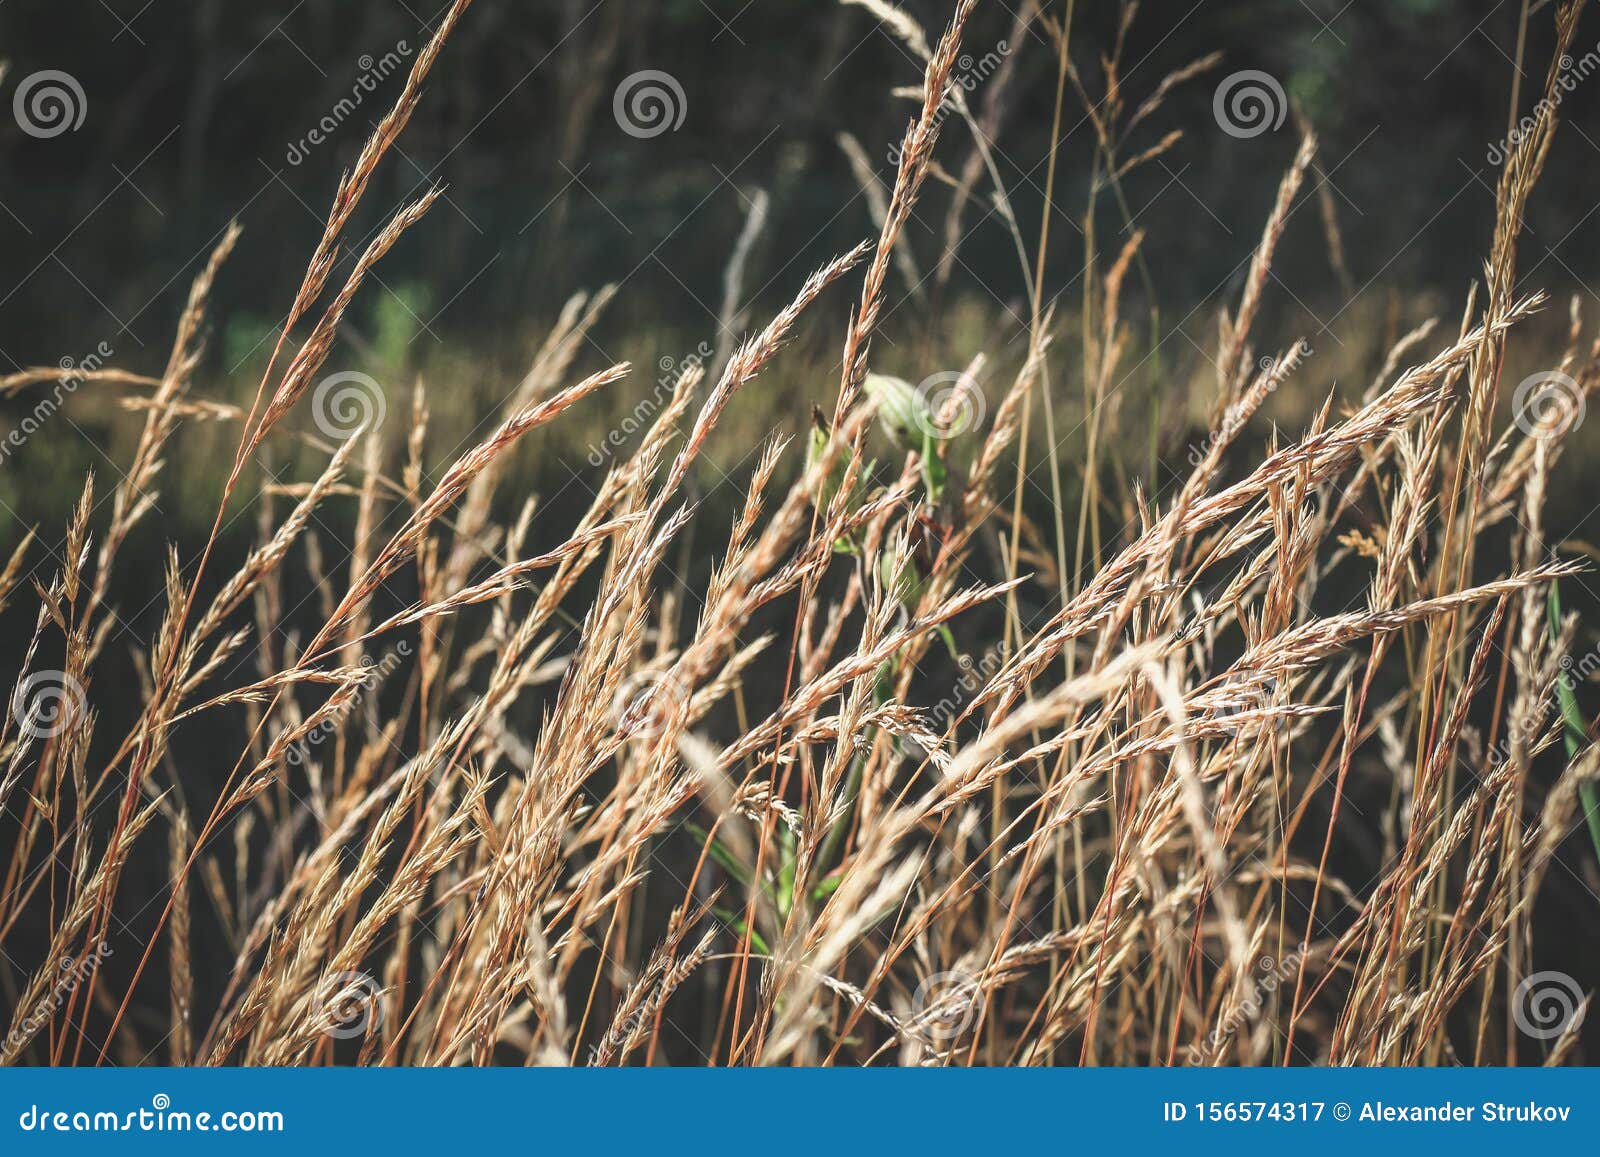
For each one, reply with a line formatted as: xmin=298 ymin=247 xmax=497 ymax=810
xmin=0 ymin=0 xmax=1600 ymax=1064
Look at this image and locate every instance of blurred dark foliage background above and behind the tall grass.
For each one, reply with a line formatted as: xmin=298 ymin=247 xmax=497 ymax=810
xmin=0 ymin=0 xmax=1600 ymax=370
